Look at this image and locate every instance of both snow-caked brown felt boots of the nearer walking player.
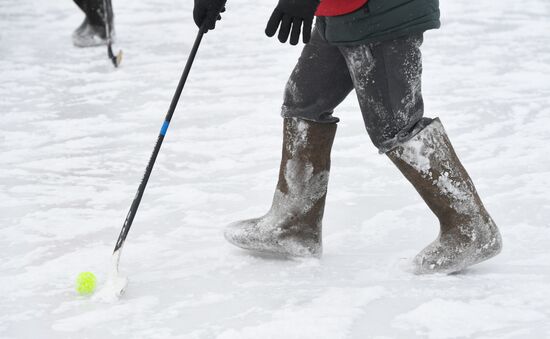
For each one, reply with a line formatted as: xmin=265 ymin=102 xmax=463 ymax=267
xmin=225 ymin=118 xmax=502 ymax=274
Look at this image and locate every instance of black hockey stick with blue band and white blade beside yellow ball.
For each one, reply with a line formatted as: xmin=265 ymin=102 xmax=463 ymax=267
xmin=94 ymin=25 xmax=206 ymax=301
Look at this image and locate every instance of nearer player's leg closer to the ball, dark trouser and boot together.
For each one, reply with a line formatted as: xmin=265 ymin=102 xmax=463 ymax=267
xmin=225 ymin=25 xmax=353 ymax=257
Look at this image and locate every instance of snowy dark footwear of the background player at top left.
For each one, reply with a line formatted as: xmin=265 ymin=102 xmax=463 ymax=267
xmin=72 ymin=0 xmax=115 ymax=47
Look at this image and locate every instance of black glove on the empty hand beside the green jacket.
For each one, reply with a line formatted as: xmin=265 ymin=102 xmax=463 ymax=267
xmin=265 ymin=0 xmax=319 ymax=45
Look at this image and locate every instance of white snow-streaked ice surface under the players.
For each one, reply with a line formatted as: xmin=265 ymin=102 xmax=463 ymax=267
xmin=0 ymin=0 xmax=550 ymax=339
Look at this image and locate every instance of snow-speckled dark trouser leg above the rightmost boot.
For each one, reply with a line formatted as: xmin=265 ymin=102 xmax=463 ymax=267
xmin=341 ymin=34 xmax=429 ymax=153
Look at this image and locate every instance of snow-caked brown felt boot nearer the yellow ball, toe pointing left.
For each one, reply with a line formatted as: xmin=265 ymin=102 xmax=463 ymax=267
xmin=225 ymin=118 xmax=336 ymax=257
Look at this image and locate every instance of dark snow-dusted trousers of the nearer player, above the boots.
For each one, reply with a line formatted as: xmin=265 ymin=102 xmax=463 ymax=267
xmin=282 ymin=22 xmax=430 ymax=153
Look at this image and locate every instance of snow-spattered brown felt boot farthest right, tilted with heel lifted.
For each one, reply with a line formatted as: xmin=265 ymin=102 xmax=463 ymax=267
xmin=387 ymin=119 xmax=502 ymax=274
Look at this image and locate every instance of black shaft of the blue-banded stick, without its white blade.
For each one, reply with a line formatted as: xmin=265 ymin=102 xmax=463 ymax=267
xmin=114 ymin=28 xmax=204 ymax=252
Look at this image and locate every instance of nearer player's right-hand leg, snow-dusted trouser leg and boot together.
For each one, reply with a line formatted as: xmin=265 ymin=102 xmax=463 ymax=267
xmin=342 ymin=35 xmax=502 ymax=273
